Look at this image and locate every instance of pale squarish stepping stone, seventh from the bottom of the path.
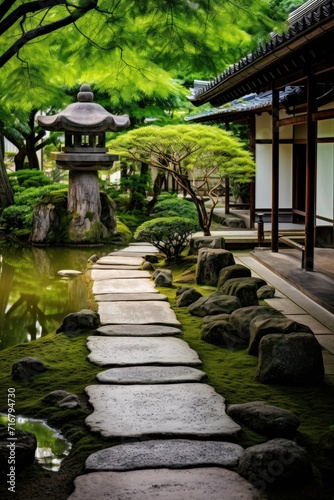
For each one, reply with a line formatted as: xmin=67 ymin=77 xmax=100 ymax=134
xmin=98 ymin=298 xmax=180 ymax=327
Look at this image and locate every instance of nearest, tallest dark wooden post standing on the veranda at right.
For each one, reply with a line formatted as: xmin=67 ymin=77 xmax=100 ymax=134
xmin=305 ymin=75 xmax=317 ymax=271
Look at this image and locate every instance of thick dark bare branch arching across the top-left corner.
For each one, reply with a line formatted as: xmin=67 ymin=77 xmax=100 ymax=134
xmin=0 ymin=0 xmax=98 ymax=68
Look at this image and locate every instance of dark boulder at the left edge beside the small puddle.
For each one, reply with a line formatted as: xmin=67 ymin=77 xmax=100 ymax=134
xmin=0 ymin=428 xmax=37 ymax=476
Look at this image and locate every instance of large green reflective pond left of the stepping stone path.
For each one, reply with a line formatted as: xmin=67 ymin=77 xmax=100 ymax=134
xmin=0 ymin=244 xmax=115 ymax=350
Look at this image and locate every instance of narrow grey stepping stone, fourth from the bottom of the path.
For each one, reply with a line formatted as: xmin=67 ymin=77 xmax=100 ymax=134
xmin=96 ymin=366 xmax=206 ymax=384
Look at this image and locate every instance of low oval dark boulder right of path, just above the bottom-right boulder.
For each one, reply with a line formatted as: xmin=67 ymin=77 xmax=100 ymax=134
xmin=227 ymin=401 xmax=300 ymax=437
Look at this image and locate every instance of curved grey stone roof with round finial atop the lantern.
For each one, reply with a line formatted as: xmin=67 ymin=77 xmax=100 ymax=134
xmin=37 ymin=84 xmax=130 ymax=133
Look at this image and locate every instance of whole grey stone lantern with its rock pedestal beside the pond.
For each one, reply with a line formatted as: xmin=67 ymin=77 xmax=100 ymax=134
xmin=30 ymin=84 xmax=130 ymax=244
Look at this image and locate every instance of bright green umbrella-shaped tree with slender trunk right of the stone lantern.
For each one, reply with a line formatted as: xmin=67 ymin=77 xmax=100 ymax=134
xmin=109 ymin=124 xmax=255 ymax=235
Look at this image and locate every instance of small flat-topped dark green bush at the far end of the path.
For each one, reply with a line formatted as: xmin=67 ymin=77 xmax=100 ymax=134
xmin=134 ymin=217 xmax=197 ymax=260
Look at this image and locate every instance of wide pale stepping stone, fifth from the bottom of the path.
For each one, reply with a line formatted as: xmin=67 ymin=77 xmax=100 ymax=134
xmin=87 ymin=336 xmax=202 ymax=366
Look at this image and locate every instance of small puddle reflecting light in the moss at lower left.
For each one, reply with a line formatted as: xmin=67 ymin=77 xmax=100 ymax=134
xmin=0 ymin=413 xmax=71 ymax=472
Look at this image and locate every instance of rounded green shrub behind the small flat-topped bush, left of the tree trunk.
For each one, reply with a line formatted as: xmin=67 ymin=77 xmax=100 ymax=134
xmin=153 ymin=193 xmax=199 ymax=221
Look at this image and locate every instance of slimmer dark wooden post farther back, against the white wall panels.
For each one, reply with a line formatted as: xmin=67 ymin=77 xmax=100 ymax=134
xmin=271 ymin=83 xmax=279 ymax=252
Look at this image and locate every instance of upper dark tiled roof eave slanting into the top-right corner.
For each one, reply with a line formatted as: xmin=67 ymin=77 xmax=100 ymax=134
xmin=188 ymin=1 xmax=334 ymax=106
